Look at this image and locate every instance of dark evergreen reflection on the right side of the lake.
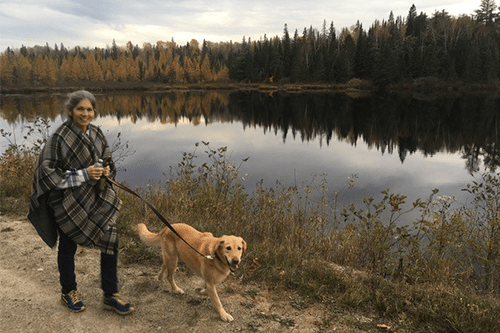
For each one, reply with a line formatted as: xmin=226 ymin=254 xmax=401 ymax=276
xmin=231 ymin=94 xmax=500 ymax=172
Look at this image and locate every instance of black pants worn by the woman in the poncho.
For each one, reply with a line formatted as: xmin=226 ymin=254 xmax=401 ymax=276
xmin=57 ymin=229 xmax=118 ymax=296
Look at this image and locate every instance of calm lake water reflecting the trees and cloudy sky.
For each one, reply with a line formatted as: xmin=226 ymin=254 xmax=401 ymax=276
xmin=0 ymin=91 xmax=500 ymax=210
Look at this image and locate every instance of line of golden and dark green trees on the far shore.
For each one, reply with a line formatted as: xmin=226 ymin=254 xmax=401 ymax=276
xmin=0 ymin=0 xmax=500 ymax=87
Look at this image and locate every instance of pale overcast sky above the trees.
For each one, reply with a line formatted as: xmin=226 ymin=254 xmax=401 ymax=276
xmin=0 ymin=0 xmax=481 ymax=52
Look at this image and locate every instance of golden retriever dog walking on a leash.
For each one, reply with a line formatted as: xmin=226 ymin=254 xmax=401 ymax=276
xmin=137 ymin=223 xmax=247 ymax=321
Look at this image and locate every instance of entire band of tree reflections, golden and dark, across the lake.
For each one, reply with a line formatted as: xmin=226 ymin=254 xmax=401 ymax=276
xmin=1 ymin=91 xmax=500 ymax=172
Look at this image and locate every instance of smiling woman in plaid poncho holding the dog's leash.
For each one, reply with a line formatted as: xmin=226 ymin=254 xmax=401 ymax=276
xmin=28 ymin=90 xmax=135 ymax=315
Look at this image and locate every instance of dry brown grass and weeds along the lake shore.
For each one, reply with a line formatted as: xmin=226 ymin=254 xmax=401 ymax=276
xmin=0 ymin=122 xmax=500 ymax=332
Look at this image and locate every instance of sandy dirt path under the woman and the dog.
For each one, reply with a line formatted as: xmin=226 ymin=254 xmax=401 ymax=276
xmin=0 ymin=215 xmax=369 ymax=333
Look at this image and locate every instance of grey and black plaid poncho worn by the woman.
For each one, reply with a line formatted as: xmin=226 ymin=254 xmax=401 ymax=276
xmin=28 ymin=118 xmax=121 ymax=254
